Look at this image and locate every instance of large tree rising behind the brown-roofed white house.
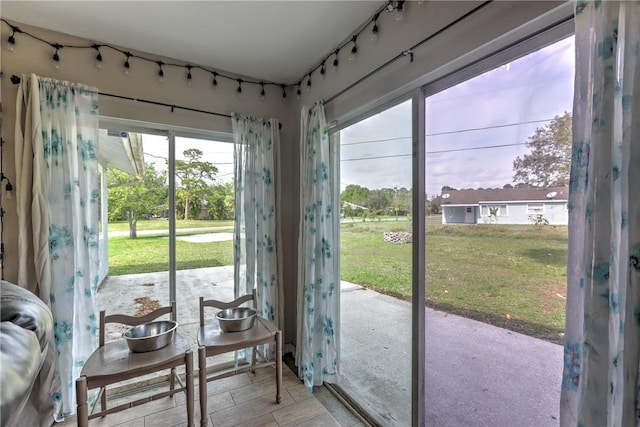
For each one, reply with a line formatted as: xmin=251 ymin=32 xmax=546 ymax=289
xmin=513 ymin=112 xmax=571 ymax=188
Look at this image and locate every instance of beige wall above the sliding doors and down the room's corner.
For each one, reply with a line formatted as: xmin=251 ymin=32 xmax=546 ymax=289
xmin=0 ymin=1 xmax=570 ymax=343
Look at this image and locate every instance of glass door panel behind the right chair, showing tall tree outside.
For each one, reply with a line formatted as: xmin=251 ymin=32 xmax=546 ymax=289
xmin=175 ymin=136 xmax=235 ymax=363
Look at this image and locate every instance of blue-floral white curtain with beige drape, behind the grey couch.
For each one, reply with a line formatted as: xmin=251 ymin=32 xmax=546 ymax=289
xmin=15 ymin=74 xmax=100 ymax=424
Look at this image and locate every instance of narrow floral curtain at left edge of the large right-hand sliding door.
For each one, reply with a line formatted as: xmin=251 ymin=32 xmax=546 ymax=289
xmin=296 ymin=101 xmax=340 ymax=389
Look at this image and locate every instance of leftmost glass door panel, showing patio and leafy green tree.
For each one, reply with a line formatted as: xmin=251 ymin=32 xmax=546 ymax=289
xmin=97 ymin=129 xmax=169 ymax=341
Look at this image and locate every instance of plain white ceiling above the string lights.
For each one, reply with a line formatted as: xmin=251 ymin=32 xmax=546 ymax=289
xmin=0 ymin=0 xmax=386 ymax=83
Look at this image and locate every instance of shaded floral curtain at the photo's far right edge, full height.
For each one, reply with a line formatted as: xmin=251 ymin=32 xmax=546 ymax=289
xmin=560 ymin=0 xmax=640 ymax=426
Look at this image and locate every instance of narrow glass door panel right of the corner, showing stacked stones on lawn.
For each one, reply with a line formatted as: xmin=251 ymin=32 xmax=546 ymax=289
xmin=338 ymin=101 xmax=412 ymax=426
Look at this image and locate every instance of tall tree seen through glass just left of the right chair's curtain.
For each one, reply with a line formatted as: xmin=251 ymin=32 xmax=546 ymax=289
xmin=175 ymin=148 xmax=218 ymax=219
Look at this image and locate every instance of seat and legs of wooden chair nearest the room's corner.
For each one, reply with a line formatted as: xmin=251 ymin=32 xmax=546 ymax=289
xmin=198 ymin=316 xmax=282 ymax=427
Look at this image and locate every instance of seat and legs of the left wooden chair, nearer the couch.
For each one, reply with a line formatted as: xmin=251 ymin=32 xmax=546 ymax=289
xmin=76 ymin=334 xmax=194 ymax=427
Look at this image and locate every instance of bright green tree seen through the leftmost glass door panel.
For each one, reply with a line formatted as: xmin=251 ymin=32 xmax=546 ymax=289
xmin=107 ymin=163 xmax=169 ymax=239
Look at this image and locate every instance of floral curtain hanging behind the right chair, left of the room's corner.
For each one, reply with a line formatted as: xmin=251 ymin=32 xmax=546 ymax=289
xmin=231 ymin=114 xmax=280 ymax=325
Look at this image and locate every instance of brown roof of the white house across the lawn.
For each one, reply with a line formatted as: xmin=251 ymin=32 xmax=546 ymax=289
xmin=441 ymin=187 xmax=569 ymax=205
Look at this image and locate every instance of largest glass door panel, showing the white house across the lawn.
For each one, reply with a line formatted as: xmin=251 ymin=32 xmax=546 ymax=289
xmin=425 ymin=37 xmax=574 ymax=426
